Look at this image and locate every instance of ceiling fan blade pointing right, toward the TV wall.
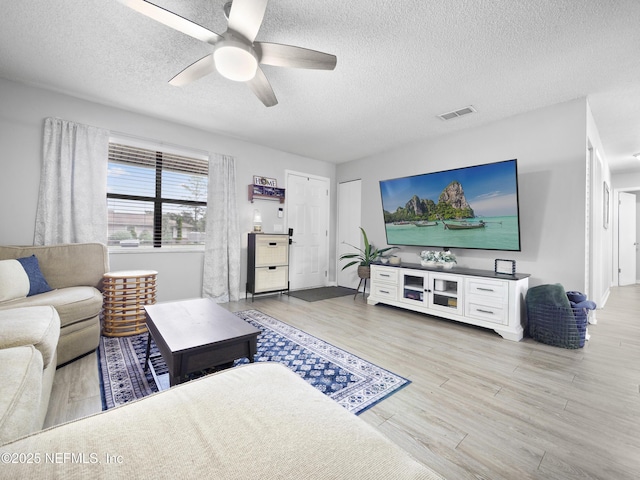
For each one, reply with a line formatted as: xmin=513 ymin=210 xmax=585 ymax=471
xmin=255 ymin=42 xmax=338 ymax=70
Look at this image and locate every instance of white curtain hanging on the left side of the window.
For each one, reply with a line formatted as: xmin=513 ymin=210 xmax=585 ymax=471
xmin=33 ymin=118 xmax=109 ymax=245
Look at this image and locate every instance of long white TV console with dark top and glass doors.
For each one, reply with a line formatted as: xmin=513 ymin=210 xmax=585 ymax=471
xmin=367 ymin=264 xmax=529 ymax=342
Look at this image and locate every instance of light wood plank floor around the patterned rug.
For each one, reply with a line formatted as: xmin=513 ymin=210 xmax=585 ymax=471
xmin=47 ymin=286 xmax=640 ymax=480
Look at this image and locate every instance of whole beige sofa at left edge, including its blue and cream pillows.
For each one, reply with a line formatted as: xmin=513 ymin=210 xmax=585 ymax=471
xmin=0 ymin=243 xmax=109 ymax=442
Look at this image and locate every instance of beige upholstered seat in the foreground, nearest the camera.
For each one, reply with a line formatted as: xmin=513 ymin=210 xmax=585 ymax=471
xmin=0 ymin=363 xmax=440 ymax=480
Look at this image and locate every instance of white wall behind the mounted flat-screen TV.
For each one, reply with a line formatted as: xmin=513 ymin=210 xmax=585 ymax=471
xmin=337 ymin=99 xmax=587 ymax=291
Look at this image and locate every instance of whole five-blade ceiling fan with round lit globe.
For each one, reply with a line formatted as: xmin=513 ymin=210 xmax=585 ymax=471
xmin=118 ymin=0 xmax=337 ymax=107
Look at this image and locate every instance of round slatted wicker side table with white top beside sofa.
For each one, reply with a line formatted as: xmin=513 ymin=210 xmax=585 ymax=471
xmin=102 ymin=270 xmax=158 ymax=337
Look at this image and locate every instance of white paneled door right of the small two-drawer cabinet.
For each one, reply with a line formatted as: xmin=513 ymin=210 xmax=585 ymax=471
xmin=286 ymin=172 xmax=330 ymax=290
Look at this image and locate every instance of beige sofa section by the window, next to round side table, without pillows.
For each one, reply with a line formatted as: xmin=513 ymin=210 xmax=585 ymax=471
xmin=0 ymin=243 xmax=109 ymax=365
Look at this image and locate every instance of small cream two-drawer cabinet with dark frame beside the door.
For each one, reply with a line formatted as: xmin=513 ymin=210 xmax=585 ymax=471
xmin=246 ymin=233 xmax=289 ymax=300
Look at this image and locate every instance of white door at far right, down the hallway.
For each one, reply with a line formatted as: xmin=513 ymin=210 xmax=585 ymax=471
xmin=618 ymin=192 xmax=637 ymax=285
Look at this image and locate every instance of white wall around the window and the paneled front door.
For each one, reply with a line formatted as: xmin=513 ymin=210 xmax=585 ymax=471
xmin=0 ymin=78 xmax=336 ymax=301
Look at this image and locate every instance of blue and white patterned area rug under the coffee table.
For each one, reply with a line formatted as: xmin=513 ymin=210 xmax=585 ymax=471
xmin=99 ymin=310 xmax=410 ymax=415
